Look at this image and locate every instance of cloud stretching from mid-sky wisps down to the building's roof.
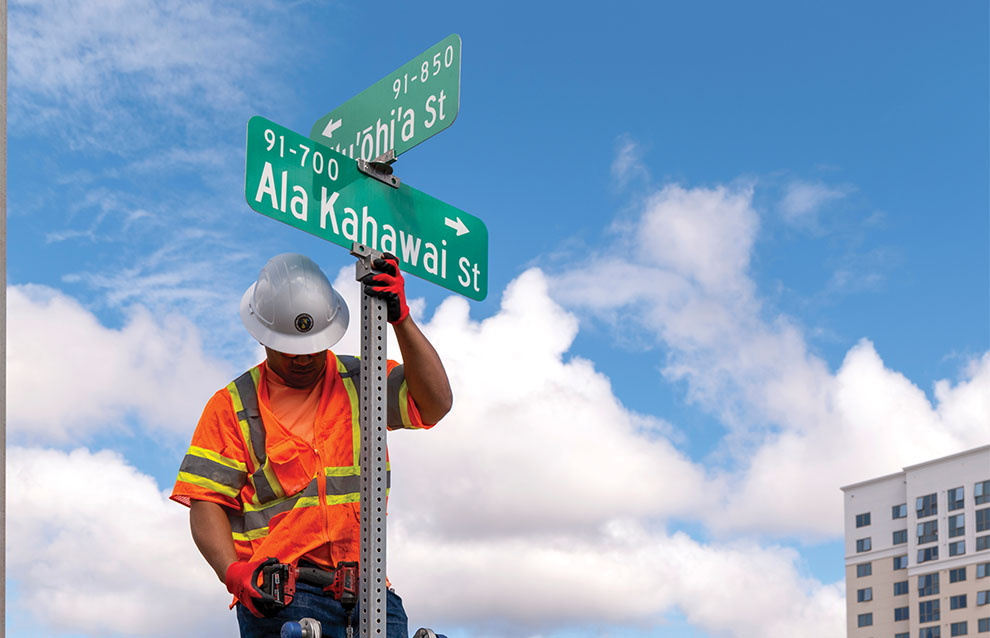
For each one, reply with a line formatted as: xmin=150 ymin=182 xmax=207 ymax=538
xmin=554 ymin=181 xmax=990 ymax=537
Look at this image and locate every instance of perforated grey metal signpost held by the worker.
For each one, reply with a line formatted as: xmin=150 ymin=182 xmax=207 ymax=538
xmin=351 ymin=242 xmax=388 ymax=638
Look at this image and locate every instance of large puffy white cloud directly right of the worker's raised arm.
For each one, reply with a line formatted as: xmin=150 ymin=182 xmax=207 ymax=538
xmin=391 ymin=270 xmax=704 ymax=538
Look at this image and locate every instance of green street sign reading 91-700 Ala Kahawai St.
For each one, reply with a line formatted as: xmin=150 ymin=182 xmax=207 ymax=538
xmin=244 ymin=116 xmax=488 ymax=301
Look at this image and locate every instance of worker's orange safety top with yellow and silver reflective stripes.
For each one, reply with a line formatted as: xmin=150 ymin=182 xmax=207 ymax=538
xmin=171 ymin=352 xmax=432 ymax=563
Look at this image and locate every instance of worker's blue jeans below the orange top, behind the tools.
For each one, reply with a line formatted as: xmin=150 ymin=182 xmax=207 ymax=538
xmin=237 ymin=582 xmax=440 ymax=638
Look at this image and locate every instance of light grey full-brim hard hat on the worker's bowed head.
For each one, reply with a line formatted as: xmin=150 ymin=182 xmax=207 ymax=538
xmin=241 ymin=253 xmax=350 ymax=354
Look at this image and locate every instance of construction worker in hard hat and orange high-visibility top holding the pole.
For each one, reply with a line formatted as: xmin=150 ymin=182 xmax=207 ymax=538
xmin=171 ymin=253 xmax=452 ymax=638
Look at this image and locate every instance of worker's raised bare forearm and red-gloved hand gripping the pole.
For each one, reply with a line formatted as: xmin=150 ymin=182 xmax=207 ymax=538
xmin=362 ymin=253 xmax=454 ymax=423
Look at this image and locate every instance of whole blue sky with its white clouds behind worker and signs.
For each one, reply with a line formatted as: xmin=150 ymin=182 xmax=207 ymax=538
xmin=7 ymin=0 xmax=990 ymax=638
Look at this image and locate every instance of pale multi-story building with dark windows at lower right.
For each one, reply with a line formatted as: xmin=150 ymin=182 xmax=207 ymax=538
xmin=842 ymin=445 xmax=990 ymax=638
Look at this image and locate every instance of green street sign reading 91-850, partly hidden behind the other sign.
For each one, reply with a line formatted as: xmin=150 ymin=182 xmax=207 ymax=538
xmin=309 ymin=33 xmax=461 ymax=161
